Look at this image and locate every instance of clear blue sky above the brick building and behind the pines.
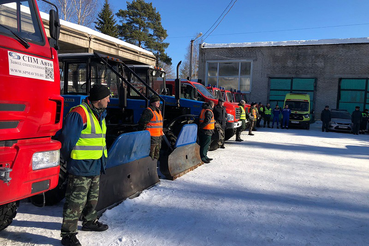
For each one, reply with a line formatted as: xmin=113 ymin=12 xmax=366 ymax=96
xmin=109 ymin=0 xmax=369 ymax=65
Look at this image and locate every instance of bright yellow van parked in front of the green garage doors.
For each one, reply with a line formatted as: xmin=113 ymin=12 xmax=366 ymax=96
xmin=283 ymin=93 xmax=310 ymax=129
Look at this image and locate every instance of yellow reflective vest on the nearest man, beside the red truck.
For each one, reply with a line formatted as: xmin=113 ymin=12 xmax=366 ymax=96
xmin=71 ymin=103 xmax=108 ymax=160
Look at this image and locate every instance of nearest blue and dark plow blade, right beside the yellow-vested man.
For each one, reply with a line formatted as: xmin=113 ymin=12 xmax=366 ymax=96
xmin=96 ymin=131 xmax=159 ymax=216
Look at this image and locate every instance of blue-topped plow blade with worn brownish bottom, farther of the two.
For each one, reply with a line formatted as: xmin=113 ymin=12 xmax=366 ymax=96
xmin=160 ymin=124 xmax=203 ymax=180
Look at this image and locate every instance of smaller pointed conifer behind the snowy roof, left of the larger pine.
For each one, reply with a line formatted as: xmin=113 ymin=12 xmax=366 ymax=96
xmin=95 ymin=0 xmax=119 ymax=38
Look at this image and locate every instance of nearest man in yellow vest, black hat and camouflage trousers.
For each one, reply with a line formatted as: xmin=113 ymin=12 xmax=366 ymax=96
xmin=59 ymin=85 xmax=110 ymax=246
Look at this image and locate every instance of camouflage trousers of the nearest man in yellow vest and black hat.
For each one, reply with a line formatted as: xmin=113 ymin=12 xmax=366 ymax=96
xmin=61 ymin=174 xmax=100 ymax=237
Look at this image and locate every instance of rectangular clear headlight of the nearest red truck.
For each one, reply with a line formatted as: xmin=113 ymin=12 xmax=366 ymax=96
xmin=32 ymin=150 xmax=60 ymax=170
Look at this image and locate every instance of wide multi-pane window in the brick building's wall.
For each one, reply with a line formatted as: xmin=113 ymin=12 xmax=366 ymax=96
xmin=206 ymin=61 xmax=252 ymax=92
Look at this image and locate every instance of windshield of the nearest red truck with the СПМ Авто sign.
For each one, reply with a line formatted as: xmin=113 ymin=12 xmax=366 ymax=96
xmin=0 ymin=0 xmax=44 ymax=44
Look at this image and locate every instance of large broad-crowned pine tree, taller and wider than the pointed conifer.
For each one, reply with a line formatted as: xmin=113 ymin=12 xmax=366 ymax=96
xmin=116 ymin=0 xmax=172 ymax=64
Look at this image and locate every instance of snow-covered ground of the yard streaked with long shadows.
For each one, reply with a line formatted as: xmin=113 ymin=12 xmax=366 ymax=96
xmin=0 ymin=123 xmax=369 ymax=246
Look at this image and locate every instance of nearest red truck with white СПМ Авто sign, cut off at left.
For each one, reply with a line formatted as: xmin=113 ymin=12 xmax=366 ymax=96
xmin=0 ymin=0 xmax=63 ymax=231
